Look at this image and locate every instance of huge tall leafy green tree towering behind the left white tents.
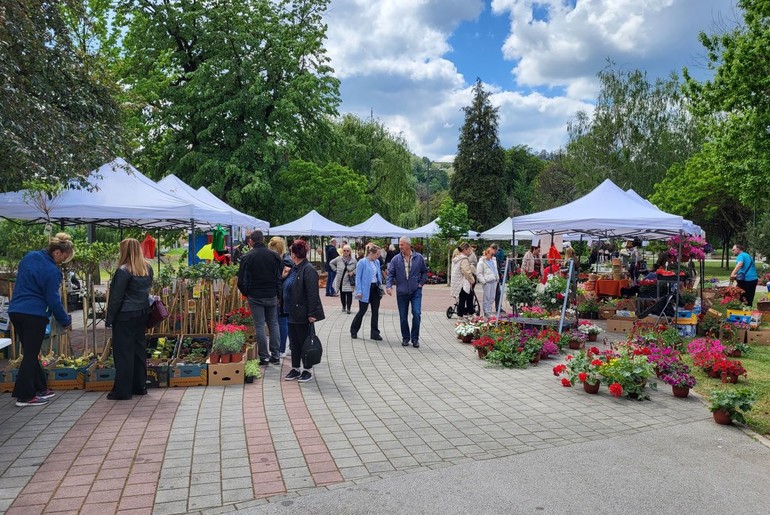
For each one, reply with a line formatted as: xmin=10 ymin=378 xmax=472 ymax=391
xmin=116 ymin=0 xmax=339 ymax=217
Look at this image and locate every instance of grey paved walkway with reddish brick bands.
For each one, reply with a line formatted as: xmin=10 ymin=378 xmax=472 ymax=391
xmin=0 ymin=286 xmax=770 ymax=515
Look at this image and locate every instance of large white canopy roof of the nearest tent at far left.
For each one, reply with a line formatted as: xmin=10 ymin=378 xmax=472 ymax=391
xmin=0 ymin=158 xmax=231 ymax=228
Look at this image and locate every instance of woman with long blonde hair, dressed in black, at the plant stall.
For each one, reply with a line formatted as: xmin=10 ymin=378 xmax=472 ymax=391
xmin=104 ymin=238 xmax=152 ymax=401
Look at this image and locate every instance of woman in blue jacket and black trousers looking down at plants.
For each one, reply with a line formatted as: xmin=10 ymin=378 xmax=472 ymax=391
xmin=8 ymin=232 xmax=75 ymax=408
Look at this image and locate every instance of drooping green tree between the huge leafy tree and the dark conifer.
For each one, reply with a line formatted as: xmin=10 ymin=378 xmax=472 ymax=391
xmin=333 ymin=114 xmax=415 ymax=225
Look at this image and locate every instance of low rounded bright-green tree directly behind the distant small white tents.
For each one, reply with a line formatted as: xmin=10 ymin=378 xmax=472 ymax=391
xmin=273 ymin=160 xmax=372 ymax=225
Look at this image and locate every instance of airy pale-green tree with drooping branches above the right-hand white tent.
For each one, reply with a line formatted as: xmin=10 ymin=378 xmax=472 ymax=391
xmin=565 ymin=63 xmax=702 ymax=197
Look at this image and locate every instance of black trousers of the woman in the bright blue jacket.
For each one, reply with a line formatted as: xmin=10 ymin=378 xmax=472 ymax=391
xmin=9 ymin=313 xmax=48 ymax=401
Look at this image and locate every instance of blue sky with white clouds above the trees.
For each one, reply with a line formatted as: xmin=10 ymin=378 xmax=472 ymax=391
xmin=325 ymin=0 xmax=739 ymax=161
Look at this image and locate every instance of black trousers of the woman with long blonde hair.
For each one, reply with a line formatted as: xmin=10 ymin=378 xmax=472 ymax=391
xmin=112 ymin=315 xmax=149 ymax=399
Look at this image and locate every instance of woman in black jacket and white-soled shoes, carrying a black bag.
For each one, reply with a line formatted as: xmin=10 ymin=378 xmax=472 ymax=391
xmin=283 ymin=240 xmax=324 ymax=383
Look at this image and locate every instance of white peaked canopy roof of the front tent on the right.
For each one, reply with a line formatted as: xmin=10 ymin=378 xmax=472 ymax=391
xmin=511 ymin=179 xmax=685 ymax=238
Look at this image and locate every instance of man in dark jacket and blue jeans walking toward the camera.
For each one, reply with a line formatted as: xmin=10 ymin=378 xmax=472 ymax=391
xmin=386 ymin=236 xmax=428 ymax=349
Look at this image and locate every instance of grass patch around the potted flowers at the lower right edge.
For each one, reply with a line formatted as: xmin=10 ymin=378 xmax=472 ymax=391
xmin=690 ymin=345 xmax=770 ymax=435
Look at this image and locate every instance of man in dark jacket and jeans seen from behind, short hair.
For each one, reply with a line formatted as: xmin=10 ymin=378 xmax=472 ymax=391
xmin=238 ymin=230 xmax=283 ymax=365
